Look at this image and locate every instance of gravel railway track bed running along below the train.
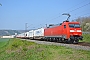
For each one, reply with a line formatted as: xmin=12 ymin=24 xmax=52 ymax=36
xmin=22 ymin=39 xmax=90 ymax=51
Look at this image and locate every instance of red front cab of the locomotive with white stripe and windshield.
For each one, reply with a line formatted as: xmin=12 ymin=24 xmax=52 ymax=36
xmin=63 ymin=22 xmax=83 ymax=43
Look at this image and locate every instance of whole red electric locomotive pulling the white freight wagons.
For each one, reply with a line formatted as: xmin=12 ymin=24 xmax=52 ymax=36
xmin=44 ymin=13 xmax=83 ymax=43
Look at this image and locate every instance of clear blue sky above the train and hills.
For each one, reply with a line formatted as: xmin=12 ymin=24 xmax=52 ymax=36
xmin=0 ymin=0 xmax=90 ymax=30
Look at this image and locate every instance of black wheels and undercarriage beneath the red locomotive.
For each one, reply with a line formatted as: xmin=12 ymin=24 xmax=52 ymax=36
xmin=44 ymin=35 xmax=83 ymax=44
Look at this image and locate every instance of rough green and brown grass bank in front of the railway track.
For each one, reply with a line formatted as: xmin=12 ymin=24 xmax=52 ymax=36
xmin=0 ymin=39 xmax=90 ymax=60
